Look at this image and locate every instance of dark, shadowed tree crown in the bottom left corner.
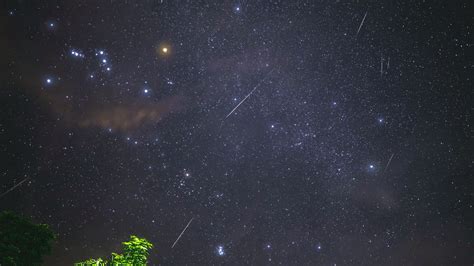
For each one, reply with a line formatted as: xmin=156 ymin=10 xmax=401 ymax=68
xmin=0 ymin=211 xmax=56 ymax=265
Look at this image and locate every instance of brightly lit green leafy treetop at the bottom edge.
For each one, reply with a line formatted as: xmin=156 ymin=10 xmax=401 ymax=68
xmin=74 ymin=235 xmax=153 ymax=266
